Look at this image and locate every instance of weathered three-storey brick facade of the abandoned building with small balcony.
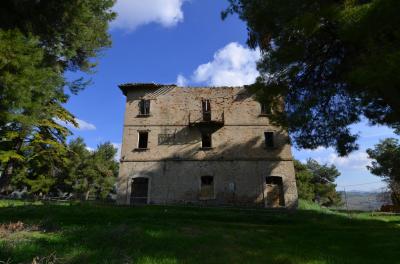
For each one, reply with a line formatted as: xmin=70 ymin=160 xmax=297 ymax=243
xmin=118 ymin=84 xmax=297 ymax=208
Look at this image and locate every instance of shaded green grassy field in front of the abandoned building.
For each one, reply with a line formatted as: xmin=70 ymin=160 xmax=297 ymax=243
xmin=0 ymin=201 xmax=400 ymax=264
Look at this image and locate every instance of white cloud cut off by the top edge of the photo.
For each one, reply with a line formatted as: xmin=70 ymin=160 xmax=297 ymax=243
xmin=111 ymin=0 xmax=186 ymax=31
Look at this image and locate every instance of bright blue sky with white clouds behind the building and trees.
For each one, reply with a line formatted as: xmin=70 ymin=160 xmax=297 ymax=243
xmin=66 ymin=0 xmax=396 ymax=191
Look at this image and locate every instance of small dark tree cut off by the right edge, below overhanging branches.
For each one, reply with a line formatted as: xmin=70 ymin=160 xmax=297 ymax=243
xmin=367 ymin=138 xmax=400 ymax=205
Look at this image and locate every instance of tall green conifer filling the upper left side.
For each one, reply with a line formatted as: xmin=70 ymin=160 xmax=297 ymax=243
xmin=0 ymin=0 xmax=115 ymax=191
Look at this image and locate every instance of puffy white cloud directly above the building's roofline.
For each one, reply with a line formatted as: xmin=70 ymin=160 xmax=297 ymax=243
xmin=186 ymin=42 xmax=261 ymax=86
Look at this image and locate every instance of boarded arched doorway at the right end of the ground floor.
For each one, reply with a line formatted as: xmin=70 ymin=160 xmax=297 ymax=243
xmin=265 ymin=176 xmax=285 ymax=207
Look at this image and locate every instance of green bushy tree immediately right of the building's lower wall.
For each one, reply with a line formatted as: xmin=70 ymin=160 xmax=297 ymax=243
xmin=294 ymin=159 xmax=341 ymax=206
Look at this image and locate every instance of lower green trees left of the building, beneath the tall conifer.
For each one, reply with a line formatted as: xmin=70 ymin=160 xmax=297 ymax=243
xmin=12 ymin=138 xmax=118 ymax=200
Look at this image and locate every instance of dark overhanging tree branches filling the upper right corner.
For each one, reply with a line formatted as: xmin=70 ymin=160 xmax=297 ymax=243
xmin=223 ymin=0 xmax=400 ymax=155
